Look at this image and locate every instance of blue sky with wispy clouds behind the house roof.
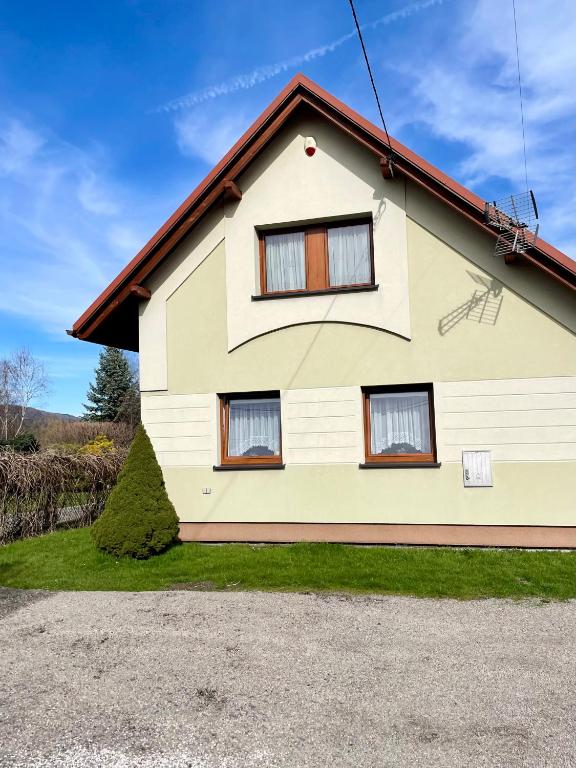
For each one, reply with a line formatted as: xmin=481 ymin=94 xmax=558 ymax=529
xmin=0 ymin=0 xmax=576 ymax=414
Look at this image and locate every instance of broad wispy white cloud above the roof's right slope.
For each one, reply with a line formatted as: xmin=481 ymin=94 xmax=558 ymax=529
xmin=388 ymin=0 xmax=576 ymax=257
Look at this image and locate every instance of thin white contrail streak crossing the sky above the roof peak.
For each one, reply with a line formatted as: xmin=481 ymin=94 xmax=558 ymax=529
xmin=153 ymin=0 xmax=444 ymax=112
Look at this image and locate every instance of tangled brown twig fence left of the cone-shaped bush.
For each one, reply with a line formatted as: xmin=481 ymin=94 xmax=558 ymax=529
xmin=0 ymin=451 xmax=126 ymax=544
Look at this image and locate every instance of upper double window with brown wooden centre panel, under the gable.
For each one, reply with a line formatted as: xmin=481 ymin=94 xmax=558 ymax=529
xmin=259 ymin=220 xmax=374 ymax=294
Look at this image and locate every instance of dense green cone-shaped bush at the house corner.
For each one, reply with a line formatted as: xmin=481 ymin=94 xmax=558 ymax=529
xmin=92 ymin=426 xmax=178 ymax=559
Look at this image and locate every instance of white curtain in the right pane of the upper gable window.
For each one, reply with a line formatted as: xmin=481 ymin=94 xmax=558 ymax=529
xmin=328 ymin=224 xmax=372 ymax=285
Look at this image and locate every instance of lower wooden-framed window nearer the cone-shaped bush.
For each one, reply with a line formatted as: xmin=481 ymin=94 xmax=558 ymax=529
xmin=220 ymin=392 xmax=282 ymax=464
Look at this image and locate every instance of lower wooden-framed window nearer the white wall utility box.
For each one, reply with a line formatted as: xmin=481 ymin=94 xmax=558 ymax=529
xmin=363 ymin=384 xmax=436 ymax=463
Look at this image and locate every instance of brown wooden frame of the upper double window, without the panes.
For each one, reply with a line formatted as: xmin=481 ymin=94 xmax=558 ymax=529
xmin=258 ymin=216 xmax=375 ymax=297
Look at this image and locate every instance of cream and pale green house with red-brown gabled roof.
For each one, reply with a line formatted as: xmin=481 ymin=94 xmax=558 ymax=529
xmin=71 ymin=75 xmax=576 ymax=547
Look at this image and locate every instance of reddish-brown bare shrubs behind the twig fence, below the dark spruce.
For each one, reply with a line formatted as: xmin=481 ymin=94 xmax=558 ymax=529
xmin=34 ymin=419 xmax=135 ymax=453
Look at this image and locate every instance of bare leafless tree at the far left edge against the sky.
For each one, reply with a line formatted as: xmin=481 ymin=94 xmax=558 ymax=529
xmin=0 ymin=347 xmax=49 ymax=440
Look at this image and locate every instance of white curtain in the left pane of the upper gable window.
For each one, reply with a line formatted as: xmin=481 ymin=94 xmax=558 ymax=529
xmin=266 ymin=232 xmax=306 ymax=291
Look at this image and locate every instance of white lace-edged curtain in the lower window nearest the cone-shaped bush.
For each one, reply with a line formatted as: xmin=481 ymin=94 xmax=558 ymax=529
xmin=228 ymin=398 xmax=280 ymax=456
